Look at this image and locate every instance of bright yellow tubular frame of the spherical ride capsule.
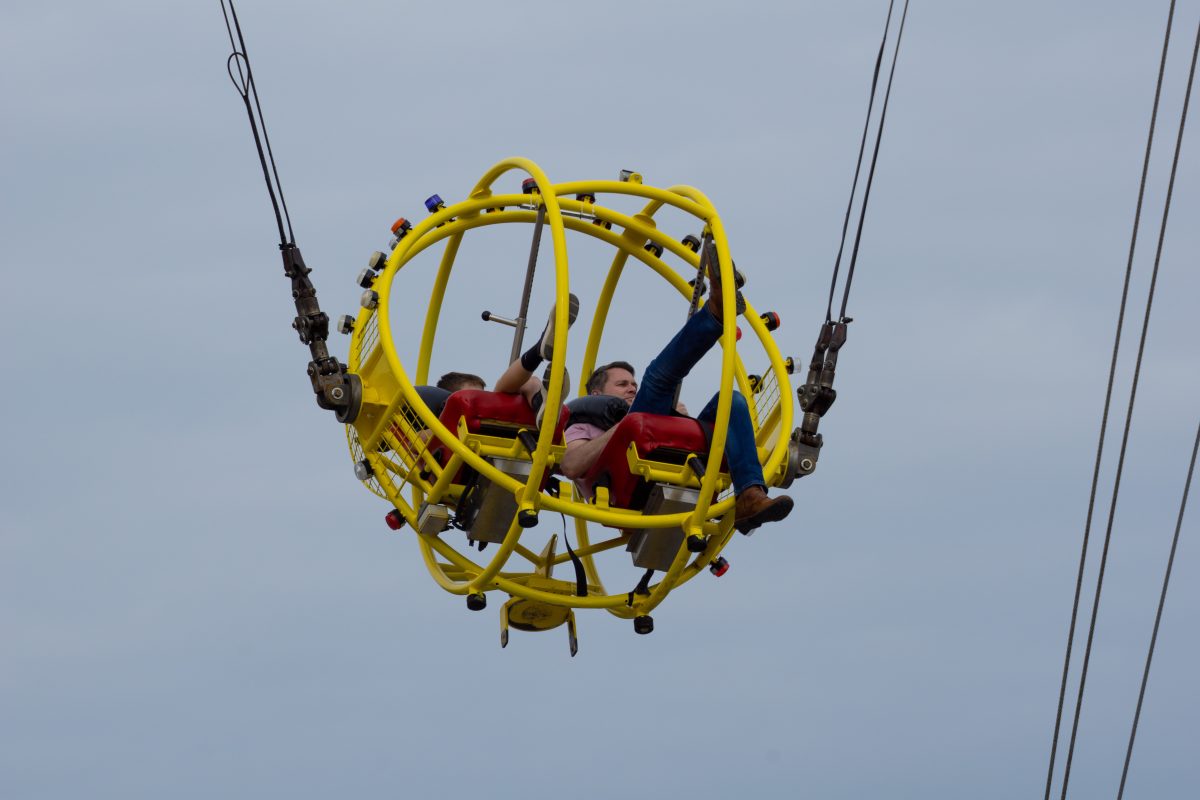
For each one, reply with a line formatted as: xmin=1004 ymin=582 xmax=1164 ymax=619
xmin=348 ymin=158 xmax=793 ymax=618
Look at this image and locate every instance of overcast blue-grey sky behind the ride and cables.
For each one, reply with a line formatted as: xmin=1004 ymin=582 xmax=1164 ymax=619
xmin=0 ymin=0 xmax=1200 ymax=800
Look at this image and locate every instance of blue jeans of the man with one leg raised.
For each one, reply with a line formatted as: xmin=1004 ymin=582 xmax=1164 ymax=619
xmin=629 ymin=307 xmax=766 ymax=494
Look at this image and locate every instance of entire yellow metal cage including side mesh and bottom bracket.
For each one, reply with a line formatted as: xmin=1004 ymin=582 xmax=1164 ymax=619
xmin=347 ymin=158 xmax=793 ymax=652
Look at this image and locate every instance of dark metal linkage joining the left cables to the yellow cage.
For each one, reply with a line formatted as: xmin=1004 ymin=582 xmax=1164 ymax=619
xmin=280 ymin=243 xmax=362 ymax=423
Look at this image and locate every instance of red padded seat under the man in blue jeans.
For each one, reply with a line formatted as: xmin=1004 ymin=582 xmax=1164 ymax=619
xmin=583 ymin=414 xmax=726 ymax=509
